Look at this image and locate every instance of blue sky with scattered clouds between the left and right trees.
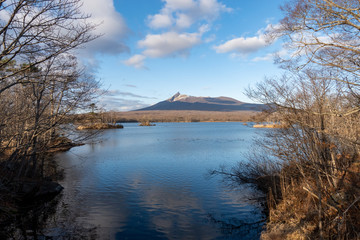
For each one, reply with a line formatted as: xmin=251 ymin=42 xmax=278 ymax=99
xmin=79 ymin=0 xmax=284 ymax=111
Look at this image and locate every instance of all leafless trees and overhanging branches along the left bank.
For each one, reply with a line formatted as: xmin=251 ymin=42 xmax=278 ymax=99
xmin=0 ymin=0 xmax=99 ymax=186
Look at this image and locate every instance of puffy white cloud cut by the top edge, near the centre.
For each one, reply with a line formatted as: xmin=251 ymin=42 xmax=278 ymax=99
xmin=148 ymin=0 xmax=231 ymax=29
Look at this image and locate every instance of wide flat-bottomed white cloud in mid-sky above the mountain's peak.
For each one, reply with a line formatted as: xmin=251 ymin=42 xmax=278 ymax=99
xmin=138 ymin=32 xmax=202 ymax=58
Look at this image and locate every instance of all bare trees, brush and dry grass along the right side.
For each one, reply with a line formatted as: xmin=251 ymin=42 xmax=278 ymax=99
xmin=211 ymin=0 xmax=360 ymax=240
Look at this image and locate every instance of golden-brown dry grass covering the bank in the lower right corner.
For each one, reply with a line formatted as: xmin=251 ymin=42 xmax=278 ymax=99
xmin=261 ymin=159 xmax=360 ymax=240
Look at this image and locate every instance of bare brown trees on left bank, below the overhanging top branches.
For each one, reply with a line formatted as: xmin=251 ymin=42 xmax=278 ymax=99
xmin=1 ymin=55 xmax=99 ymax=180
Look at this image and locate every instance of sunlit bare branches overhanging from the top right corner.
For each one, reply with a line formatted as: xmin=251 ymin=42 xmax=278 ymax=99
xmin=269 ymin=0 xmax=360 ymax=107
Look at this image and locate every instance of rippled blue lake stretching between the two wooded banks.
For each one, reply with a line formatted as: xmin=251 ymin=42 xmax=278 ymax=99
xmin=49 ymin=122 xmax=263 ymax=239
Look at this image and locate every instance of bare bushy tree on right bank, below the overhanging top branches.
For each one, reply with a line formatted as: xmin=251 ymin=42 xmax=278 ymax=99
xmin=245 ymin=68 xmax=360 ymax=239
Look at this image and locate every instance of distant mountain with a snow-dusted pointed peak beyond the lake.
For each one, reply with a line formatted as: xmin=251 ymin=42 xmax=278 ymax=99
xmin=135 ymin=92 xmax=265 ymax=112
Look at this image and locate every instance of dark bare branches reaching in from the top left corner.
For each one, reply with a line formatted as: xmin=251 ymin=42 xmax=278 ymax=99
xmin=0 ymin=0 xmax=97 ymax=94
